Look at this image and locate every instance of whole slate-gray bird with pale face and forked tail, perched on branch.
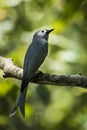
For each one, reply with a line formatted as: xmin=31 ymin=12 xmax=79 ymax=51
xmin=10 ymin=29 xmax=54 ymax=117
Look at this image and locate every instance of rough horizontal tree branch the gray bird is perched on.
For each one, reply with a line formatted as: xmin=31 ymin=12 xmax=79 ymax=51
xmin=0 ymin=56 xmax=87 ymax=88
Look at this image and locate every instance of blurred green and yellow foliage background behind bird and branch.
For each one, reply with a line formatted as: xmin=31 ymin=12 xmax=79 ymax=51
xmin=0 ymin=0 xmax=87 ymax=130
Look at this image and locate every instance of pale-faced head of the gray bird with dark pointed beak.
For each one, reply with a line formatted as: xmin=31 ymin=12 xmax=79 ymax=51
xmin=34 ymin=29 xmax=54 ymax=40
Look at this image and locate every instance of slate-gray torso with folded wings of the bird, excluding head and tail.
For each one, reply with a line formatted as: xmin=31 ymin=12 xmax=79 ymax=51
xmin=23 ymin=41 xmax=48 ymax=82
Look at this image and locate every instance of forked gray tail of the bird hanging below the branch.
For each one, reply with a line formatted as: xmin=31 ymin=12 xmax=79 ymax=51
xmin=10 ymin=87 xmax=27 ymax=117
